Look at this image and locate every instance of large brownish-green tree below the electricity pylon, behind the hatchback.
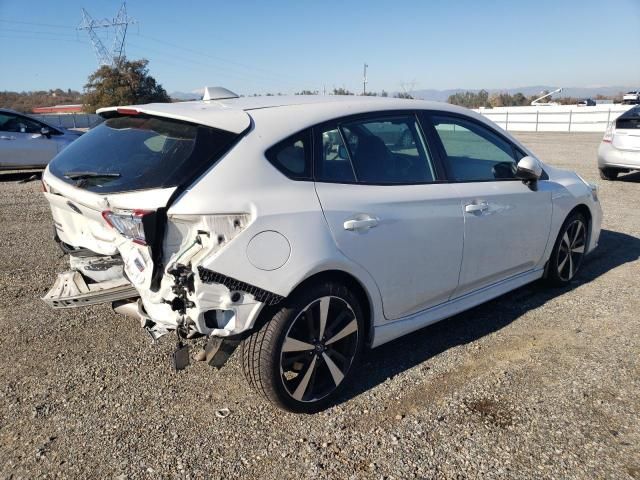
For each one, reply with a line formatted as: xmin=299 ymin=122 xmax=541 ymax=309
xmin=84 ymin=59 xmax=171 ymax=112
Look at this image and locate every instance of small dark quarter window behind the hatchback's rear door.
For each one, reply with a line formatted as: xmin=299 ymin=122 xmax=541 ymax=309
xmin=265 ymin=130 xmax=311 ymax=180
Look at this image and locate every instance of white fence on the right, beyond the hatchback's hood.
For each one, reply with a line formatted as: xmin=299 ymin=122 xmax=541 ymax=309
xmin=475 ymin=105 xmax=632 ymax=132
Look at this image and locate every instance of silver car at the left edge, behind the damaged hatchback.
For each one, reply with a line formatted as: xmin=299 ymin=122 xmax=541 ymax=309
xmin=0 ymin=109 xmax=82 ymax=170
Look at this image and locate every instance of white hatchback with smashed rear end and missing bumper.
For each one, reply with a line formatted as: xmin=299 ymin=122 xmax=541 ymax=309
xmin=43 ymin=90 xmax=602 ymax=412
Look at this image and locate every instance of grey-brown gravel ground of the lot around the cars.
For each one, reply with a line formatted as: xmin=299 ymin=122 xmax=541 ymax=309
xmin=0 ymin=133 xmax=640 ymax=479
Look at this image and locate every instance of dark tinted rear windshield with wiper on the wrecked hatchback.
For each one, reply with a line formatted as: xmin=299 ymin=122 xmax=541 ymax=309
xmin=49 ymin=115 xmax=239 ymax=193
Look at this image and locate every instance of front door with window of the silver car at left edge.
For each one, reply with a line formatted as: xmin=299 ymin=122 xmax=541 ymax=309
xmin=0 ymin=112 xmax=58 ymax=168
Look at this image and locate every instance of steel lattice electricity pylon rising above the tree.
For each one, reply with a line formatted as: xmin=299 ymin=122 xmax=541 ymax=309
xmin=78 ymin=2 xmax=137 ymax=67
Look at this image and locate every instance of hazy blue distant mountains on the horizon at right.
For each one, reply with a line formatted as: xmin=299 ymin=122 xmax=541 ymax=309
xmin=411 ymin=85 xmax=635 ymax=102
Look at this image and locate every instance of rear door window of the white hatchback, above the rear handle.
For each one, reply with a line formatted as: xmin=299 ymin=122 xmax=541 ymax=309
xmin=316 ymin=115 xmax=435 ymax=185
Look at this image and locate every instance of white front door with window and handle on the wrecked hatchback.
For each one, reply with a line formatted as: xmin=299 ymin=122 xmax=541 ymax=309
xmin=425 ymin=113 xmax=552 ymax=297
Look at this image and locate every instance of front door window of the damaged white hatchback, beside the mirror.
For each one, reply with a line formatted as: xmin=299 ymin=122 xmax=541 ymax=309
xmin=431 ymin=115 xmax=522 ymax=182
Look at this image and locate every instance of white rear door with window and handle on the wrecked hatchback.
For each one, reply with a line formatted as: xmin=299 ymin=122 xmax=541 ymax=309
xmin=314 ymin=112 xmax=464 ymax=319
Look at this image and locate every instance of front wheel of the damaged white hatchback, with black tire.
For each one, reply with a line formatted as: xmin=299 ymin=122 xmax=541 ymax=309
xmin=546 ymin=212 xmax=589 ymax=287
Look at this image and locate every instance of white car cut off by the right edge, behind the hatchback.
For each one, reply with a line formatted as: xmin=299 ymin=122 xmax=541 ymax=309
xmin=598 ymin=106 xmax=640 ymax=180
